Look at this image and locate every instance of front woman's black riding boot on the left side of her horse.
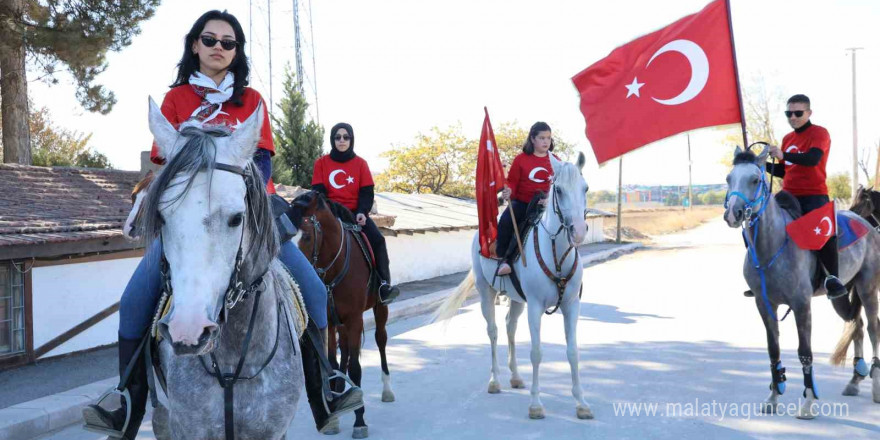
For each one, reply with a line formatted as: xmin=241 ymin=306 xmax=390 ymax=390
xmin=83 ymin=338 xmax=150 ymax=440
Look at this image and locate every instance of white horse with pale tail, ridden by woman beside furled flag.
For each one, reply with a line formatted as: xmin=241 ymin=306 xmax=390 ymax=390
xmin=434 ymin=153 xmax=593 ymax=419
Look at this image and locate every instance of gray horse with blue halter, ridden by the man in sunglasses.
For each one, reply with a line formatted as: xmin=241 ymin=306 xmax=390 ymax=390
xmin=724 ymin=147 xmax=880 ymax=419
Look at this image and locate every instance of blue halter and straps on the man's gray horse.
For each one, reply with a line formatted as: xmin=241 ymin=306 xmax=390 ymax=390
xmin=724 ymin=164 xmax=791 ymax=321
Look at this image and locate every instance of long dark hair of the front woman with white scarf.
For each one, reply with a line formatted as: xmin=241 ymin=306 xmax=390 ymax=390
xmin=171 ymin=10 xmax=250 ymax=106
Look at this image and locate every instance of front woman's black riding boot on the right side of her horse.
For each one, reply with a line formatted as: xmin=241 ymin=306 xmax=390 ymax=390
xmin=300 ymin=320 xmax=364 ymax=432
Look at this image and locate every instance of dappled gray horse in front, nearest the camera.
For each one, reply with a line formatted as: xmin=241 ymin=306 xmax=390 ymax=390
xmin=142 ymin=100 xmax=306 ymax=440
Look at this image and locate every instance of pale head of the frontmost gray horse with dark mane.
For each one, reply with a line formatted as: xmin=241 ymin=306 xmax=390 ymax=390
xmin=141 ymin=99 xmax=278 ymax=355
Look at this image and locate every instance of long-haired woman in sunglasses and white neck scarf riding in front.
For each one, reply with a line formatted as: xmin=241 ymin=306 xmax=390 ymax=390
xmin=83 ymin=11 xmax=363 ymax=440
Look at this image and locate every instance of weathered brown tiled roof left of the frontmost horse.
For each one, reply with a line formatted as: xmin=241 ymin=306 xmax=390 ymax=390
xmin=0 ymin=164 xmax=139 ymax=249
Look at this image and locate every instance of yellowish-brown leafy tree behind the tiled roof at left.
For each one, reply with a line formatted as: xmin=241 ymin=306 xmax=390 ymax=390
xmin=0 ymin=107 xmax=112 ymax=168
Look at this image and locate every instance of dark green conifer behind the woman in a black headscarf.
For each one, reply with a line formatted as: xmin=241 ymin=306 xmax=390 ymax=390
xmin=272 ymin=67 xmax=324 ymax=188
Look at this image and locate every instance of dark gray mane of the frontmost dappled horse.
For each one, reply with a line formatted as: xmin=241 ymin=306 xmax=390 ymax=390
xmin=140 ymin=125 xmax=279 ymax=268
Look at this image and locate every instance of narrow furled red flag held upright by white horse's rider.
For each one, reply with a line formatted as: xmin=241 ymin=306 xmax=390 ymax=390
xmin=476 ymin=107 xmax=504 ymax=257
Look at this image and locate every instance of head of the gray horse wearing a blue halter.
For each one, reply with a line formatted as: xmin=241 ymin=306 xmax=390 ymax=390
xmin=724 ymin=146 xmax=770 ymax=228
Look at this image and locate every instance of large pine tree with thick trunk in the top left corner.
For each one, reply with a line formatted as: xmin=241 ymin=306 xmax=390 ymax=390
xmin=0 ymin=0 xmax=160 ymax=164
